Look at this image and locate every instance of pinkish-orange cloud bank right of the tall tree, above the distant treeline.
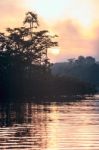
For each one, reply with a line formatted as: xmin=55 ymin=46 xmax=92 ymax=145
xmin=48 ymin=20 xmax=99 ymax=61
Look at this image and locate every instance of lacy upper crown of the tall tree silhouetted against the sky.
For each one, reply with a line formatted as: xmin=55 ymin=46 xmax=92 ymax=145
xmin=0 ymin=12 xmax=57 ymax=67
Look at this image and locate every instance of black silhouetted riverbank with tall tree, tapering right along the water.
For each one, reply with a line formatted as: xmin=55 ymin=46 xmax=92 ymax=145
xmin=0 ymin=12 xmax=96 ymax=101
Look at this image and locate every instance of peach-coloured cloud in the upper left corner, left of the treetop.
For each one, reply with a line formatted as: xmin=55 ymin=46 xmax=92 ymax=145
xmin=0 ymin=0 xmax=25 ymax=30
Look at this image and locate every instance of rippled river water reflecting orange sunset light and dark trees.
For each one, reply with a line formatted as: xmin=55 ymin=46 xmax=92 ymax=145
xmin=0 ymin=98 xmax=99 ymax=150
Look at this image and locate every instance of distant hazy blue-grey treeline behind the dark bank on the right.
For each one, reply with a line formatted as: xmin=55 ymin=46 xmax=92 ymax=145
xmin=52 ymin=56 xmax=99 ymax=89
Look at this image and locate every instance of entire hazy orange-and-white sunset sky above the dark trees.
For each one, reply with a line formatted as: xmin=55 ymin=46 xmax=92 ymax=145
xmin=0 ymin=0 xmax=99 ymax=62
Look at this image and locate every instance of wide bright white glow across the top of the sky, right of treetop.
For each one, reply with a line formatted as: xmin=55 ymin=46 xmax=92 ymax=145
xmin=25 ymin=0 xmax=93 ymax=27
